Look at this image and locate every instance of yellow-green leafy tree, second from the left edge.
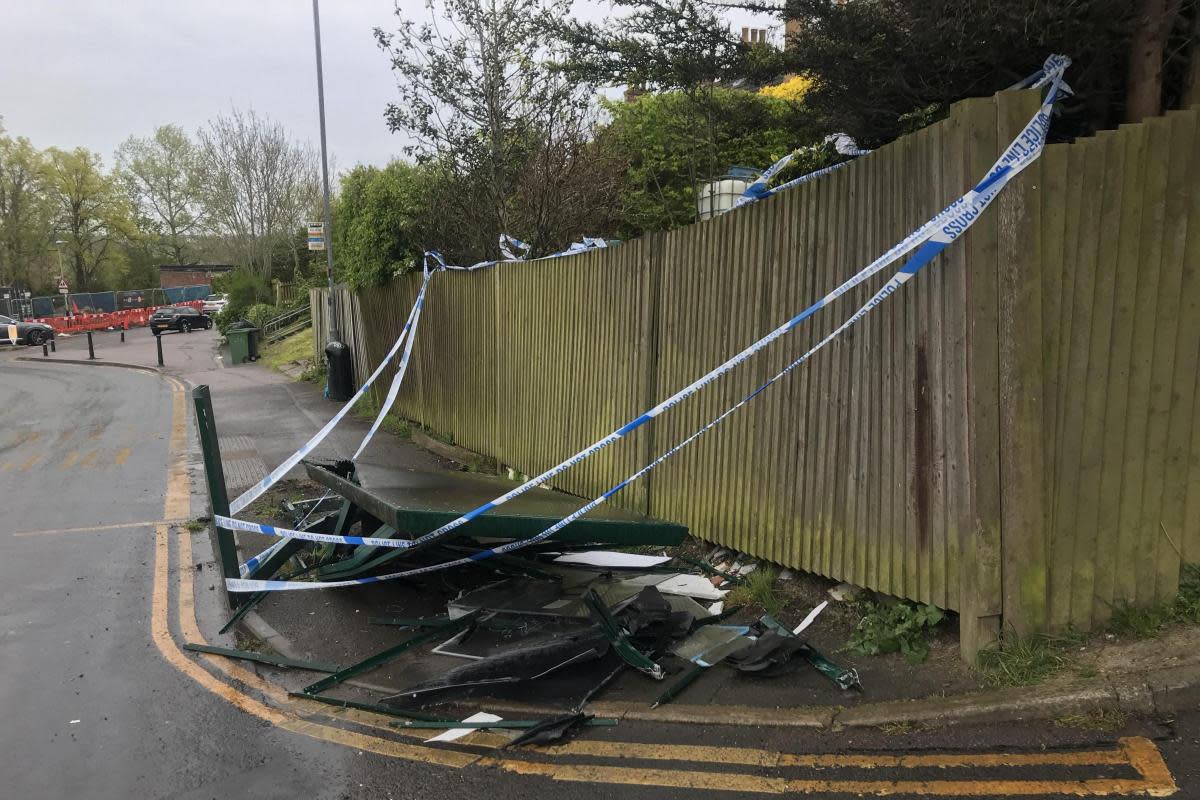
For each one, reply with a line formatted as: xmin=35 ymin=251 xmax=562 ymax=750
xmin=46 ymin=148 xmax=137 ymax=291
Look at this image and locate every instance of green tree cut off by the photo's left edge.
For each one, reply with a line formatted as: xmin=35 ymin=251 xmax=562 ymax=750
xmin=0 ymin=136 xmax=52 ymax=287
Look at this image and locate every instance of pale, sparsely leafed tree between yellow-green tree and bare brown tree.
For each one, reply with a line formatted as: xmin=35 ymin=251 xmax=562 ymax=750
xmin=116 ymin=125 xmax=204 ymax=264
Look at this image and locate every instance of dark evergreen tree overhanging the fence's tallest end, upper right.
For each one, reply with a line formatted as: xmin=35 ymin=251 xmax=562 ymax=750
xmin=772 ymin=0 xmax=1195 ymax=146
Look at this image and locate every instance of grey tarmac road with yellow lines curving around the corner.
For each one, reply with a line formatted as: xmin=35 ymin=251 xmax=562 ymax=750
xmin=0 ymin=354 xmax=1200 ymax=800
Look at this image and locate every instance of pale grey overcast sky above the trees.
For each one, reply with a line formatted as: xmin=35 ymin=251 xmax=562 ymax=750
xmin=0 ymin=0 xmax=777 ymax=169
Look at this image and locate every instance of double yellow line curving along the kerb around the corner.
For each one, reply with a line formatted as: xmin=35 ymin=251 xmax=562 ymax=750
xmin=151 ymin=378 xmax=1177 ymax=796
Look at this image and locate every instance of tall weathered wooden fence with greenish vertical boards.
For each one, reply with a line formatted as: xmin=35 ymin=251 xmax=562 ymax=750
xmin=312 ymin=91 xmax=1200 ymax=654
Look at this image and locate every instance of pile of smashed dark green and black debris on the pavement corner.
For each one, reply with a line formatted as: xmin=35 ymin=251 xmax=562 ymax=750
xmin=204 ymin=463 xmax=860 ymax=746
